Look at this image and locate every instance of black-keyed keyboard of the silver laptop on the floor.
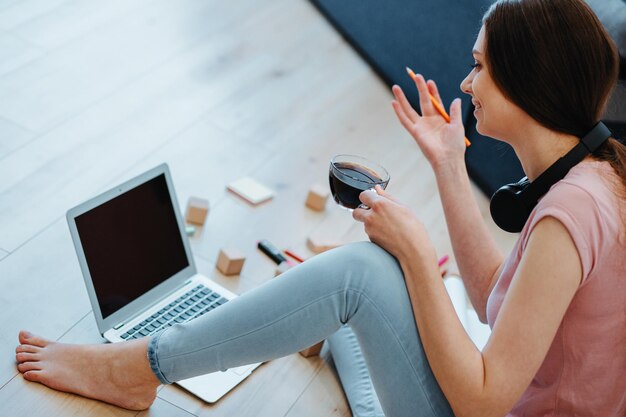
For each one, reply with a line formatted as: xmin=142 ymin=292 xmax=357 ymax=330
xmin=120 ymin=285 xmax=228 ymax=340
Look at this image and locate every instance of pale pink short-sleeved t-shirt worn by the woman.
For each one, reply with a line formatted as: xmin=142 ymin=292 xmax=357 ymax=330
xmin=487 ymin=160 xmax=626 ymax=417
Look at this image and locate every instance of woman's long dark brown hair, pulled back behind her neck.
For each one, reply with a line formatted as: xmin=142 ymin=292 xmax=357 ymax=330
xmin=483 ymin=0 xmax=626 ymax=199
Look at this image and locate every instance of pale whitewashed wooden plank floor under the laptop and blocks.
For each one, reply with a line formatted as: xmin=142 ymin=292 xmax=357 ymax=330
xmin=0 ymin=0 xmax=512 ymax=417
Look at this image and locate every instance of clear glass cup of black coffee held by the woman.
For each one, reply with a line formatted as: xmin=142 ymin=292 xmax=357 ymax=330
xmin=328 ymin=155 xmax=390 ymax=210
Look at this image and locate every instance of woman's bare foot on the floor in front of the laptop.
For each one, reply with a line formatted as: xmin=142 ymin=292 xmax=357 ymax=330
xmin=15 ymin=331 xmax=160 ymax=410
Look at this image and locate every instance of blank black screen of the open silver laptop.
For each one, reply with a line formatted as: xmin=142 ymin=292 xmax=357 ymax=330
xmin=76 ymin=174 xmax=189 ymax=318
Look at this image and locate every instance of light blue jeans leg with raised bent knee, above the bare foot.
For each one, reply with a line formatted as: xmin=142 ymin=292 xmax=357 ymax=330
xmin=148 ymin=242 xmax=453 ymax=417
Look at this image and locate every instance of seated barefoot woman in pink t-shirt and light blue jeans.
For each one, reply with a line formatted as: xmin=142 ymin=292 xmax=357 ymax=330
xmin=16 ymin=0 xmax=626 ymax=416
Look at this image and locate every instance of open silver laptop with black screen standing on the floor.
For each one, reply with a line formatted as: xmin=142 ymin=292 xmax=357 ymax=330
xmin=67 ymin=164 xmax=261 ymax=403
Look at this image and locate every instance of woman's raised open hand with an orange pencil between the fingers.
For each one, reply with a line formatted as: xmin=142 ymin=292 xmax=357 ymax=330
xmin=391 ymin=74 xmax=465 ymax=169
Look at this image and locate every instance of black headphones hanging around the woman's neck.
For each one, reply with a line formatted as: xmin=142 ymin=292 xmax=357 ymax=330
xmin=489 ymin=122 xmax=612 ymax=233
